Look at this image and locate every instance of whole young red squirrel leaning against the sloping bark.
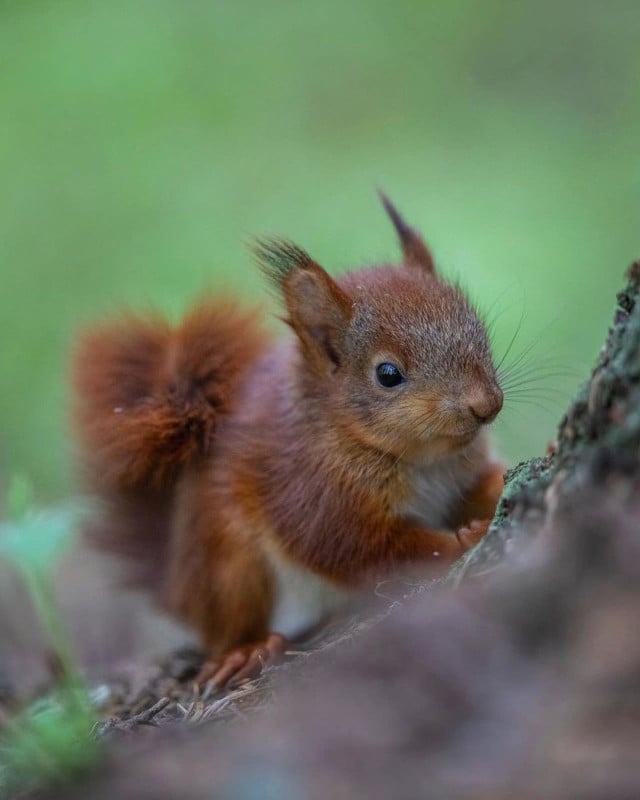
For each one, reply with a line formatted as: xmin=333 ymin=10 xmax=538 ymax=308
xmin=73 ymin=196 xmax=503 ymax=686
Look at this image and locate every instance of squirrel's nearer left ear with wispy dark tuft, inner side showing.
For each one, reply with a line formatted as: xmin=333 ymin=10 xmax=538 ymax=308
xmin=253 ymin=239 xmax=353 ymax=375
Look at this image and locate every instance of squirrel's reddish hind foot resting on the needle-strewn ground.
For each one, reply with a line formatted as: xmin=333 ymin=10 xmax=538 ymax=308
xmin=195 ymin=633 xmax=289 ymax=690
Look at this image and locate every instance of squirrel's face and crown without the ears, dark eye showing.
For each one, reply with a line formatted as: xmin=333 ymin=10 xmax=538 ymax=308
xmin=331 ymin=267 xmax=502 ymax=458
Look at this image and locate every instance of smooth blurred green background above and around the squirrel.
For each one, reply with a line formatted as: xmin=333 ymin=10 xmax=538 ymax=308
xmin=0 ymin=0 xmax=640 ymax=499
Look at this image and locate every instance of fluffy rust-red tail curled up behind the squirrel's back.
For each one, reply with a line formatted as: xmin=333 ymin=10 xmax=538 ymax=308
xmin=72 ymin=299 xmax=264 ymax=583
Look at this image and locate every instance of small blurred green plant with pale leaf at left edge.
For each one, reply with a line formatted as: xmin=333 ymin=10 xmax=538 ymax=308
xmin=0 ymin=477 xmax=96 ymax=797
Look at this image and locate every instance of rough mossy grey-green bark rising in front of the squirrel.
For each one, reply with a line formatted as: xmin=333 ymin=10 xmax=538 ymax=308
xmin=453 ymin=261 xmax=640 ymax=578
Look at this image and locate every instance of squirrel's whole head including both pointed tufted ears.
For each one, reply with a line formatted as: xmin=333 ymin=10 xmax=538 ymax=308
xmin=254 ymin=195 xmax=503 ymax=460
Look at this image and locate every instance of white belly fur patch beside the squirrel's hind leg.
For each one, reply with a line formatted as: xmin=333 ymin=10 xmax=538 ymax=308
xmin=267 ymin=549 xmax=354 ymax=639
